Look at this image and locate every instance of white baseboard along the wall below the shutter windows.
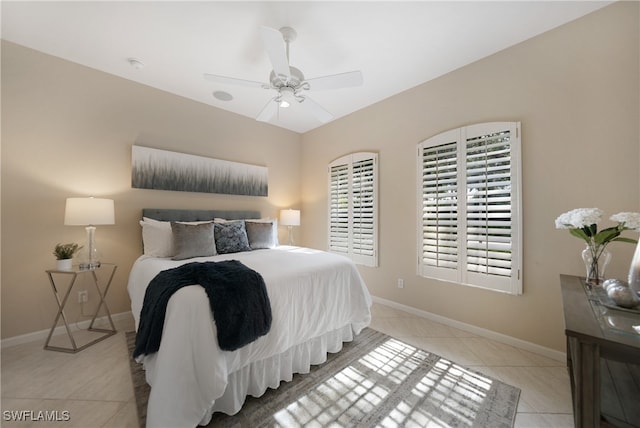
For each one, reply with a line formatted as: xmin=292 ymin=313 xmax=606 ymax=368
xmin=372 ymin=296 xmax=567 ymax=362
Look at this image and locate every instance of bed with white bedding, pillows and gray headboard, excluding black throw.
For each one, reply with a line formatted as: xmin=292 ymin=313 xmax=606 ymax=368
xmin=128 ymin=209 xmax=371 ymax=427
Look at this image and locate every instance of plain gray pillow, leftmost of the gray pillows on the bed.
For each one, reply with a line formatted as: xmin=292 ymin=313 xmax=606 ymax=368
xmin=171 ymin=222 xmax=217 ymax=260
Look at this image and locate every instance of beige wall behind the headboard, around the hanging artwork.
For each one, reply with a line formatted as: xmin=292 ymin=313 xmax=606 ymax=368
xmin=2 ymin=42 xmax=301 ymax=338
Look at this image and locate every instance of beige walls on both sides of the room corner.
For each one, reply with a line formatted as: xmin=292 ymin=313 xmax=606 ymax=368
xmin=1 ymin=2 xmax=640 ymax=349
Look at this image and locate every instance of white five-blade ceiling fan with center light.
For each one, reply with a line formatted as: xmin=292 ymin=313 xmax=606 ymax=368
xmin=204 ymin=27 xmax=362 ymax=123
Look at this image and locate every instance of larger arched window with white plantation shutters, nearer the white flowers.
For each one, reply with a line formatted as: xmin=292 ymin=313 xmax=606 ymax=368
xmin=418 ymin=122 xmax=522 ymax=294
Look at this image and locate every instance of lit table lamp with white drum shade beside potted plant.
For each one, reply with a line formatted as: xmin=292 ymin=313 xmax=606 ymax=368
xmin=64 ymin=197 xmax=115 ymax=269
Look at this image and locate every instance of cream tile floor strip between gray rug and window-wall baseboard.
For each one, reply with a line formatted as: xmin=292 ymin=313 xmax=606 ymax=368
xmin=371 ymin=304 xmax=573 ymax=428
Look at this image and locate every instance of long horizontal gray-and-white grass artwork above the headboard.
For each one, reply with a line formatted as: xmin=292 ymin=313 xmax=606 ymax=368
xmin=131 ymin=146 xmax=269 ymax=196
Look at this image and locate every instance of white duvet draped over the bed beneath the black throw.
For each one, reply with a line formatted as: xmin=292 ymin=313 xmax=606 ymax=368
xmin=128 ymin=246 xmax=371 ymax=427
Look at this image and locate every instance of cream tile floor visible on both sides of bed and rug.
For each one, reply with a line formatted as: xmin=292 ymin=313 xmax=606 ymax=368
xmin=0 ymin=304 xmax=573 ymax=428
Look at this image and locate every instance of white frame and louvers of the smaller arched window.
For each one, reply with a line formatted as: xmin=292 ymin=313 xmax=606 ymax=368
xmin=327 ymin=152 xmax=379 ymax=267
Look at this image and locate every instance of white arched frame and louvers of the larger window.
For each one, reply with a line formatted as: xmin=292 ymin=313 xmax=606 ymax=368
xmin=416 ymin=122 xmax=522 ymax=295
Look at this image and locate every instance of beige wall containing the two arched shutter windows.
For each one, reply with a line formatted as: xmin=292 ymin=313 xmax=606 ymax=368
xmin=302 ymin=2 xmax=640 ymax=350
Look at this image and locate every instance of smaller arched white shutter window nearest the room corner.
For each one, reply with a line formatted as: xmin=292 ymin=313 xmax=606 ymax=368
xmin=329 ymin=152 xmax=378 ymax=266
